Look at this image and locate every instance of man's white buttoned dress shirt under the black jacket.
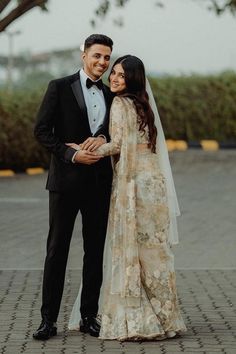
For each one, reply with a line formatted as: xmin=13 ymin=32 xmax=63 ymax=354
xmin=80 ymin=69 xmax=106 ymax=135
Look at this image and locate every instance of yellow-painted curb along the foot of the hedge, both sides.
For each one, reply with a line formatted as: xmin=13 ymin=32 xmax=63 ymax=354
xmin=0 ymin=139 xmax=236 ymax=178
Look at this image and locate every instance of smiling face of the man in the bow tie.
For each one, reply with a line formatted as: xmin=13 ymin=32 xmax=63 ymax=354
xmin=82 ymin=44 xmax=111 ymax=80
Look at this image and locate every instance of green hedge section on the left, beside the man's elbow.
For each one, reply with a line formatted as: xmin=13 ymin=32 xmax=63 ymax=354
xmin=0 ymin=91 xmax=49 ymax=171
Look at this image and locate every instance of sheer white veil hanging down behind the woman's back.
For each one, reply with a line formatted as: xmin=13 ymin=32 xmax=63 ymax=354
xmin=146 ymin=79 xmax=180 ymax=245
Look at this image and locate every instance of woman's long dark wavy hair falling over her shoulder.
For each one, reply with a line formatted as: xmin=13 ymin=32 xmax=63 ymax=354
xmin=109 ymin=55 xmax=157 ymax=152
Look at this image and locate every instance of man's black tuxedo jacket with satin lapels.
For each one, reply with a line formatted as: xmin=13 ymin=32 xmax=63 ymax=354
xmin=34 ymin=69 xmax=113 ymax=192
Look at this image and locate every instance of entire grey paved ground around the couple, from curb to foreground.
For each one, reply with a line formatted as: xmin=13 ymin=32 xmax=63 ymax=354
xmin=0 ymin=150 xmax=236 ymax=354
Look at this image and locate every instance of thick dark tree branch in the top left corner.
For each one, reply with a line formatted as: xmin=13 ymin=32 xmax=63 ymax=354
xmin=0 ymin=0 xmax=48 ymax=32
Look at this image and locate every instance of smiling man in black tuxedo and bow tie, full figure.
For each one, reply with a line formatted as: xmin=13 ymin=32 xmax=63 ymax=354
xmin=33 ymin=34 xmax=113 ymax=340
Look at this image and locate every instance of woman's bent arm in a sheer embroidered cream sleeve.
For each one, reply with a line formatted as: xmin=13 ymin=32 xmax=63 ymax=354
xmin=96 ymin=97 xmax=125 ymax=156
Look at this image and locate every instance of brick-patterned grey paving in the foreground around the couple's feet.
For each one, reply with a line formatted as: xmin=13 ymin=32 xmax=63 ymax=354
xmin=0 ymin=270 xmax=236 ymax=354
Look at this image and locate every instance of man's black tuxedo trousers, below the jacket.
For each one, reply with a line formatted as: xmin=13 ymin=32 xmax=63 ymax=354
xmin=41 ymin=173 xmax=111 ymax=322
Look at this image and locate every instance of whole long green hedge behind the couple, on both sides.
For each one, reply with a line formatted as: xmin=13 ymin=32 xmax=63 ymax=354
xmin=0 ymin=72 xmax=236 ymax=170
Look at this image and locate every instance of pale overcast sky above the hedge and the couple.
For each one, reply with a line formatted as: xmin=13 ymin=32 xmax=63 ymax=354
xmin=0 ymin=0 xmax=236 ymax=74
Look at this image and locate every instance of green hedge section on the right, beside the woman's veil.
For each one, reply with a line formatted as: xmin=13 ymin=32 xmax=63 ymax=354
xmin=150 ymin=72 xmax=236 ymax=141
